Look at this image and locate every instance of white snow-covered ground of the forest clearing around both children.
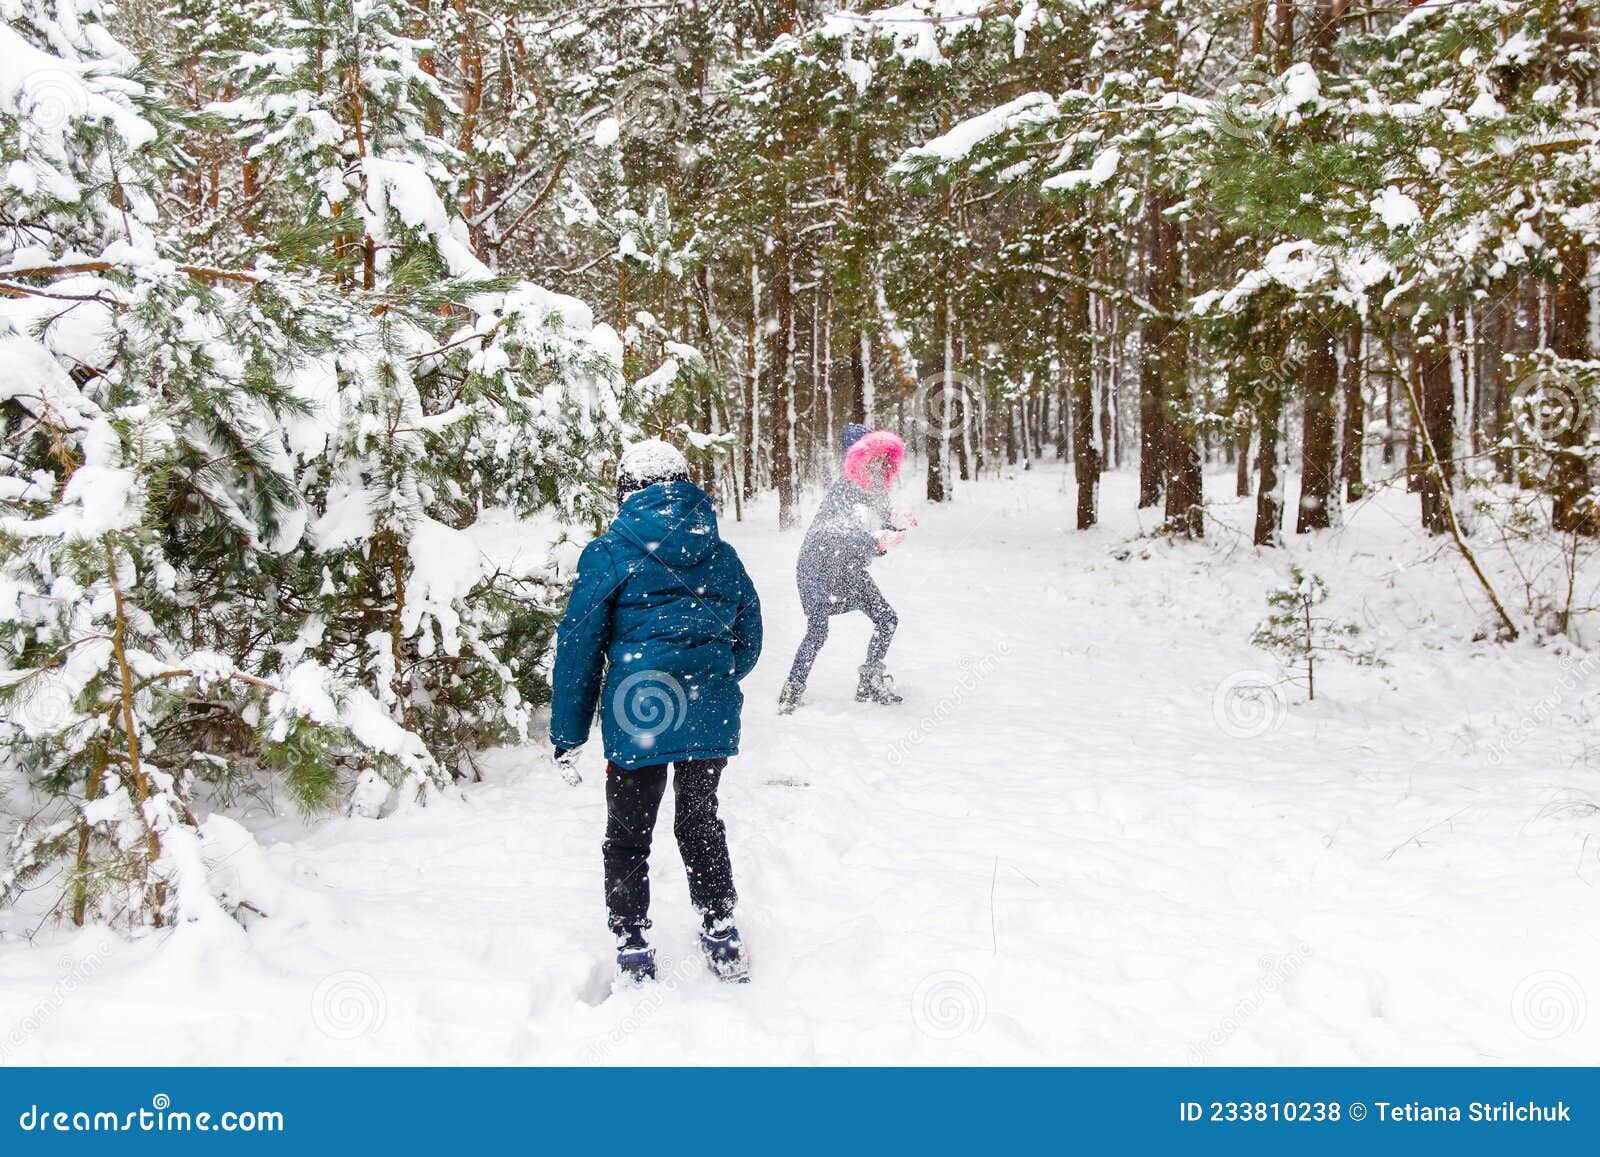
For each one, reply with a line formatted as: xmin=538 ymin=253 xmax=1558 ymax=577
xmin=0 ymin=464 xmax=1600 ymax=1064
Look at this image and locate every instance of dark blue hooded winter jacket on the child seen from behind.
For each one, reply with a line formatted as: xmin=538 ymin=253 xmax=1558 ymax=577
xmin=550 ymin=482 xmax=762 ymax=768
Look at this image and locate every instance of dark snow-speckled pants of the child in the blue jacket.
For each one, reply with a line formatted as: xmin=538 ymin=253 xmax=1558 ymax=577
xmin=603 ymin=759 xmax=738 ymax=936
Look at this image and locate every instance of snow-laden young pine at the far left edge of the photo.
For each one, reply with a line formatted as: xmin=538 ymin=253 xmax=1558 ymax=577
xmin=0 ymin=0 xmax=457 ymax=925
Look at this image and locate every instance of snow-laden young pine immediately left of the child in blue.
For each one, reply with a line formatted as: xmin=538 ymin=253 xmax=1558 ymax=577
xmin=201 ymin=3 xmax=648 ymax=774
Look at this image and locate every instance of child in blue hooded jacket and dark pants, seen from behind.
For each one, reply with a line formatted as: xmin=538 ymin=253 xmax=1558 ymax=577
xmin=550 ymin=442 xmax=762 ymax=981
